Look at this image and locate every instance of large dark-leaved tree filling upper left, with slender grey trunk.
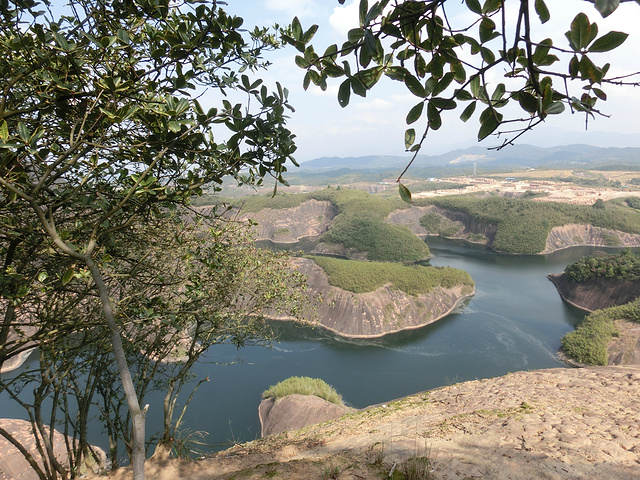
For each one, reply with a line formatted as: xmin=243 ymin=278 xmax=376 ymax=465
xmin=0 ymin=0 xmax=295 ymax=479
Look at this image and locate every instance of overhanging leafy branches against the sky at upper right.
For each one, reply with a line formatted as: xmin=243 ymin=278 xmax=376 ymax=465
xmin=283 ymin=0 xmax=639 ymax=199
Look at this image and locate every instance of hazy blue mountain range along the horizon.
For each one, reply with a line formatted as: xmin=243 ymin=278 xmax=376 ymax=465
xmin=297 ymin=145 xmax=640 ymax=174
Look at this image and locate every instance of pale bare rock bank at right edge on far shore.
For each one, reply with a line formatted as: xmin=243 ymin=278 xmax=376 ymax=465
xmin=541 ymin=225 xmax=640 ymax=253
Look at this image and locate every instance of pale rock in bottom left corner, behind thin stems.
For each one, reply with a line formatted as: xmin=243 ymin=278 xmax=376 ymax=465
xmin=0 ymin=418 xmax=107 ymax=480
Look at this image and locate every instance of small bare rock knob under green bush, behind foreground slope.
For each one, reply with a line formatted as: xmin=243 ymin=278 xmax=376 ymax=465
xmin=258 ymin=394 xmax=354 ymax=437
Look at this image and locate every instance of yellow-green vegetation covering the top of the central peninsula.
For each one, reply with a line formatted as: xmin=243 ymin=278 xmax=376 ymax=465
xmin=309 ymin=256 xmax=474 ymax=296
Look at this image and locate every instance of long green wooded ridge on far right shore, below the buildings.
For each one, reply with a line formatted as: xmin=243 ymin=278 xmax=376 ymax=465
xmin=416 ymin=196 xmax=640 ymax=254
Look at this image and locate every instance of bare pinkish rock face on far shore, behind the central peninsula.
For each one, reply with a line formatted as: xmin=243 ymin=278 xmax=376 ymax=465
xmin=242 ymin=200 xmax=338 ymax=243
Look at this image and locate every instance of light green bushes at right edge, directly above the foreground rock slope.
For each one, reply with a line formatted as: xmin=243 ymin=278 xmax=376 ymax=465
xmin=562 ymin=298 xmax=640 ymax=365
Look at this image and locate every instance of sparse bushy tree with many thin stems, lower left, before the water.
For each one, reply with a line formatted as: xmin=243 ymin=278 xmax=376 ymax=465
xmin=0 ymin=214 xmax=304 ymax=479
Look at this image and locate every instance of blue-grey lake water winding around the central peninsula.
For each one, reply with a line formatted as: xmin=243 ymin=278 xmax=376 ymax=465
xmin=1 ymin=238 xmax=632 ymax=454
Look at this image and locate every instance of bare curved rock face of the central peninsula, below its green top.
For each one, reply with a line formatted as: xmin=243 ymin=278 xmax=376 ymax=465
xmin=280 ymin=258 xmax=474 ymax=338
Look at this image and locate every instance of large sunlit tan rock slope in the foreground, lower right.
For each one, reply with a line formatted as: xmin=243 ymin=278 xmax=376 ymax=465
xmin=97 ymin=367 xmax=640 ymax=480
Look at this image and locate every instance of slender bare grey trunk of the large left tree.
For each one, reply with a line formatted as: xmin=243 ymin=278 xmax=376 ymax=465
xmin=85 ymin=258 xmax=146 ymax=480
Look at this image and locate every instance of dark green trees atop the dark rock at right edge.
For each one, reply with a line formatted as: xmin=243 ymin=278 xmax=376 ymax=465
xmin=564 ymin=250 xmax=640 ymax=284
